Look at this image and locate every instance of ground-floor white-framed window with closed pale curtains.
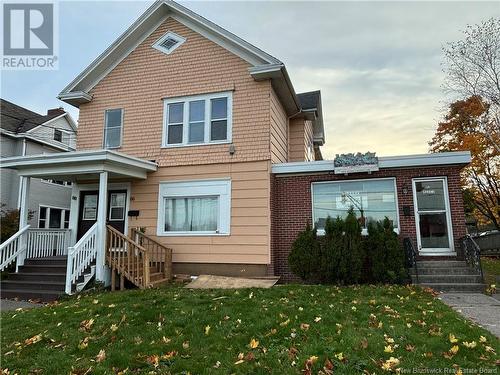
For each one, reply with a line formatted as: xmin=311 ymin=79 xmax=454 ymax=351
xmin=157 ymin=179 xmax=231 ymax=236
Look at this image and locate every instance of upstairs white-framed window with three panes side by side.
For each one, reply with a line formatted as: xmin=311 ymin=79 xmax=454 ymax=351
xmin=162 ymin=92 xmax=233 ymax=147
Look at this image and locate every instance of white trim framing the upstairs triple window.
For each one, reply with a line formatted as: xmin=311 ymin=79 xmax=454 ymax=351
xmin=161 ymin=91 xmax=233 ymax=148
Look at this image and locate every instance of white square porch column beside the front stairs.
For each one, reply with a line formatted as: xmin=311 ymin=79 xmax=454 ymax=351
xmin=95 ymin=172 xmax=111 ymax=286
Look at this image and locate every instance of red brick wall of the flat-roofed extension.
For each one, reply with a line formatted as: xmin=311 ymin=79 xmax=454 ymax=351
xmin=270 ymin=166 xmax=466 ymax=281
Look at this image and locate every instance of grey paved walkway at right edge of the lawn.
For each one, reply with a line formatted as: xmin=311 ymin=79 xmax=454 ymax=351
xmin=438 ymin=293 xmax=500 ymax=337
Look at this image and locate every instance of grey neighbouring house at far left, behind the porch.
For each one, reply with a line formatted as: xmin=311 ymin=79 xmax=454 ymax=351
xmin=0 ymin=99 xmax=76 ymax=228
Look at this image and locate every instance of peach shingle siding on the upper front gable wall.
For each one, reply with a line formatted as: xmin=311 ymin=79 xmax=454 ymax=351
xmin=77 ymin=18 xmax=271 ymax=166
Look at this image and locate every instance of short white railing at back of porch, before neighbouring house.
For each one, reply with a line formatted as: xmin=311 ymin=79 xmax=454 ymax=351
xmin=26 ymin=229 xmax=70 ymax=258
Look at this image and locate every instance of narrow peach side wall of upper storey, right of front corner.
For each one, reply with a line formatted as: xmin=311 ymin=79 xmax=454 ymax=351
xmin=270 ymin=89 xmax=288 ymax=163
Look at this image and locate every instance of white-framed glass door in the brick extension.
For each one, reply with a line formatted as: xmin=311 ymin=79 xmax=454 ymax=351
xmin=413 ymin=178 xmax=454 ymax=255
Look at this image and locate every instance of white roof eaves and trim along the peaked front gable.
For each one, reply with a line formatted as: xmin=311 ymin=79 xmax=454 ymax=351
xmin=58 ymin=0 xmax=300 ymax=115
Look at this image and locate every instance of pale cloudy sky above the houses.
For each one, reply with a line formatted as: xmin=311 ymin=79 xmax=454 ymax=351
xmin=1 ymin=1 xmax=500 ymax=159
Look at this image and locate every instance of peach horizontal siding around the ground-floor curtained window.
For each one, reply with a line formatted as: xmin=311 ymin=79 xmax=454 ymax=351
xmin=129 ymin=161 xmax=270 ymax=264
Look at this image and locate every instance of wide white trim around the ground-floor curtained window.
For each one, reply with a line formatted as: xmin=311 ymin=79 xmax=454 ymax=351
xmin=156 ymin=178 xmax=231 ymax=237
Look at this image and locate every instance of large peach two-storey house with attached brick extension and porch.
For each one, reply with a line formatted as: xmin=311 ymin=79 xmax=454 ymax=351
xmin=2 ymin=1 xmax=478 ymax=302
